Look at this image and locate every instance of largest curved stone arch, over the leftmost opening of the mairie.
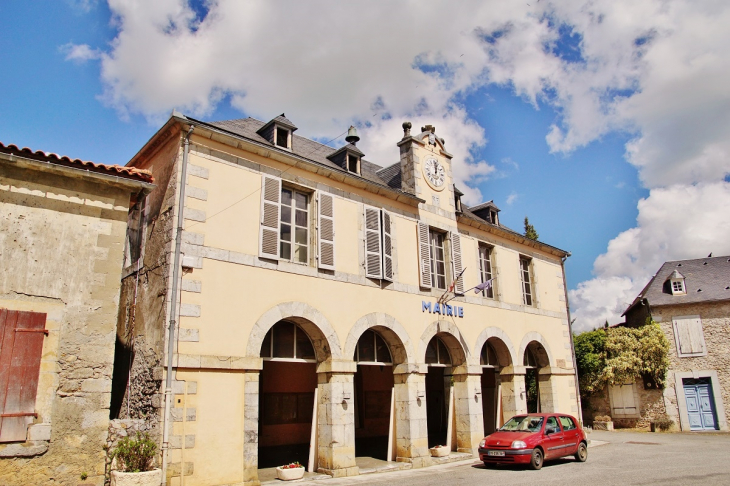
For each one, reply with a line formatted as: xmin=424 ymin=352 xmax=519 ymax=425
xmin=246 ymin=302 xmax=342 ymax=362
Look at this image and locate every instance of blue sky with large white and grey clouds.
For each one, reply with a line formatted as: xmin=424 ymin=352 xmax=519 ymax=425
xmin=0 ymin=0 xmax=730 ymax=332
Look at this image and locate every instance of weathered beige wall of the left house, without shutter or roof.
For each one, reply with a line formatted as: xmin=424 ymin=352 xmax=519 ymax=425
xmin=0 ymin=161 xmax=139 ymax=485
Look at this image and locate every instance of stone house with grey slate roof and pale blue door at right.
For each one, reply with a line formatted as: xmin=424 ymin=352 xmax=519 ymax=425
xmin=609 ymin=256 xmax=730 ymax=431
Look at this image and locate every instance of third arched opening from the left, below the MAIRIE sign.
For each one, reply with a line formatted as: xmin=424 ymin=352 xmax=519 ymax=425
xmin=426 ymin=335 xmax=453 ymax=447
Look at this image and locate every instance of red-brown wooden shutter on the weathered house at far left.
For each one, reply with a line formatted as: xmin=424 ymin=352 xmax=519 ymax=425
xmin=0 ymin=309 xmax=47 ymax=442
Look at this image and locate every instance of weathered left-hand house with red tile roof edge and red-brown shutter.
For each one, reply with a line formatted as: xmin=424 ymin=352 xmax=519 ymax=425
xmin=0 ymin=143 xmax=154 ymax=486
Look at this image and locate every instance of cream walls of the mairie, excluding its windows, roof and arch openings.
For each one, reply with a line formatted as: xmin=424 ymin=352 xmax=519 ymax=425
xmin=122 ymin=114 xmax=578 ymax=486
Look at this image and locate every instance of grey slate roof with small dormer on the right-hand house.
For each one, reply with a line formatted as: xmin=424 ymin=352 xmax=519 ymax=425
xmin=623 ymin=256 xmax=730 ymax=315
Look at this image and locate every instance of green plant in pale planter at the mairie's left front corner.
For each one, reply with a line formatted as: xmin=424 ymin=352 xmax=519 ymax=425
xmin=111 ymin=432 xmax=162 ymax=486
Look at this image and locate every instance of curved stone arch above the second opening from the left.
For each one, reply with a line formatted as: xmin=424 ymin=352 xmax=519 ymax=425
xmin=343 ymin=312 xmax=416 ymax=365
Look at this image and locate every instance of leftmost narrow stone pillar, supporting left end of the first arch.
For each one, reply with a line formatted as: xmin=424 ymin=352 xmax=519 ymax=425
xmin=243 ymin=370 xmax=261 ymax=486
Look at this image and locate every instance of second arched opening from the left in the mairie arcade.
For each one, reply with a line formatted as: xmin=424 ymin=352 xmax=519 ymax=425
xmin=353 ymin=329 xmax=394 ymax=461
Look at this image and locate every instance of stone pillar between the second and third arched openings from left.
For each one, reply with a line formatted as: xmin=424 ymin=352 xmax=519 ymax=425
xmin=393 ymin=364 xmax=431 ymax=468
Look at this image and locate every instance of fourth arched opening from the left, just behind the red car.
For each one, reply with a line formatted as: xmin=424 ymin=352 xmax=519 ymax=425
xmin=479 ymin=337 xmax=512 ymax=435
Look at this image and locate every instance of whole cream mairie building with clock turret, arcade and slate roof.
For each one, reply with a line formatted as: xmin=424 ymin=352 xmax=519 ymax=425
xmin=112 ymin=112 xmax=578 ymax=486
